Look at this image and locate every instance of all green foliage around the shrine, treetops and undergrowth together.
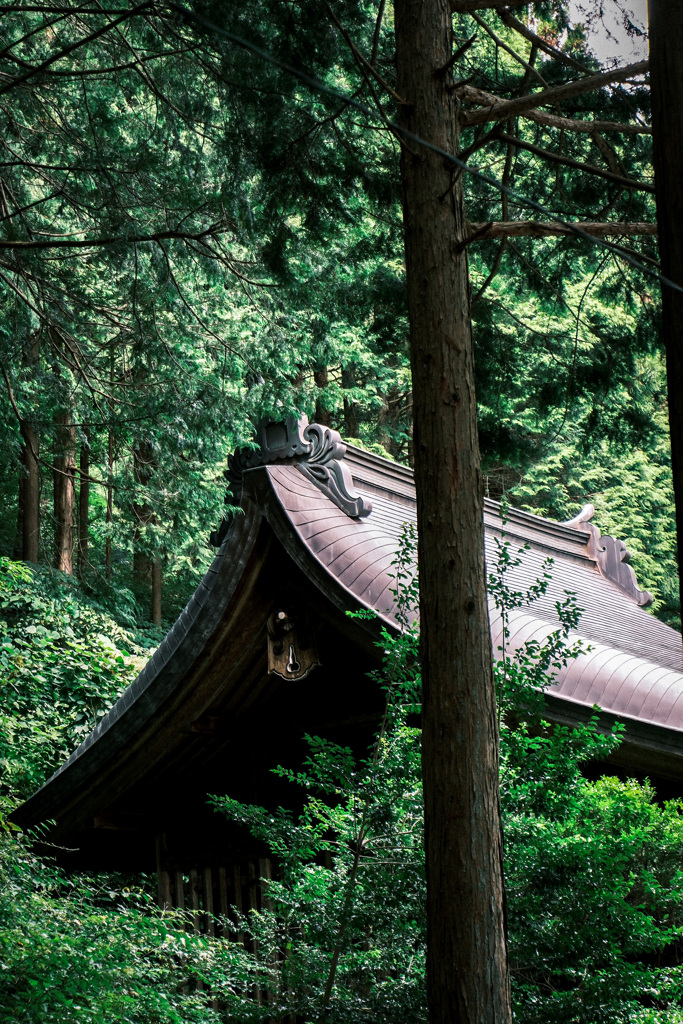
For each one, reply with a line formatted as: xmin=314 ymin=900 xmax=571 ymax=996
xmin=0 ymin=0 xmax=683 ymax=1024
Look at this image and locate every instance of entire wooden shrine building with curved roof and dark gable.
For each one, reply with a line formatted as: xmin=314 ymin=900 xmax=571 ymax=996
xmin=13 ymin=420 xmax=683 ymax=927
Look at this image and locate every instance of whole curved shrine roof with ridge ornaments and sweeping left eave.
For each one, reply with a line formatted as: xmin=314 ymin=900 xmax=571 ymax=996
xmin=15 ymin=423 xmax=683 ymax=822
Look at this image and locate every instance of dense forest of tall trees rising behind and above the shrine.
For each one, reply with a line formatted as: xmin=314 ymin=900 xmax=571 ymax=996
xmin=0 ymin=2 xmax=677 ymax=621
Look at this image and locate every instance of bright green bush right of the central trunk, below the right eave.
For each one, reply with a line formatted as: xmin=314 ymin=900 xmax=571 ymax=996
xmin=502 ymin=770 xmax=683 ymax=1024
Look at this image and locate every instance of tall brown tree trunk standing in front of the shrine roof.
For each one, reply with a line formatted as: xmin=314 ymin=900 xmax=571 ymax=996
xmin=394 ymin=0 xmax=510 ymax=1024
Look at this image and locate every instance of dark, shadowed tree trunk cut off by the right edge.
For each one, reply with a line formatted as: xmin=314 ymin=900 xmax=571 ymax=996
xmin=648 ymin=0 xmax=683 ymax=613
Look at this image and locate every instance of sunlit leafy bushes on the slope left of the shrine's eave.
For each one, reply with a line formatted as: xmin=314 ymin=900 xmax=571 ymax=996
xmin=0 ymin=558 xmax=148 ymax=799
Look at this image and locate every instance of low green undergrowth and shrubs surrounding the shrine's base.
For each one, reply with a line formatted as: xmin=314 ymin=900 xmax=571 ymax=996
xmin=0 ymin=540 xmax=683 ymax=1024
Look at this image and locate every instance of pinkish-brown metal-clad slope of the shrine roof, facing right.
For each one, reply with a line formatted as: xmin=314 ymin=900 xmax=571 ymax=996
xmin=267 ymin=449 xmax=683 ymax=731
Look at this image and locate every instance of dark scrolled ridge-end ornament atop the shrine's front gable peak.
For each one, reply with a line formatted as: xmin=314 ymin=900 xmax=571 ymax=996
xmin=211 ymin=416 xmax=373 ymax=547
